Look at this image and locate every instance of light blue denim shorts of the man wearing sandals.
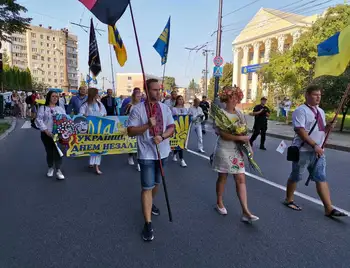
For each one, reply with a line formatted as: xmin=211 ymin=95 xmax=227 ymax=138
xmin=289 ymin=152 xmax=326 ymax=182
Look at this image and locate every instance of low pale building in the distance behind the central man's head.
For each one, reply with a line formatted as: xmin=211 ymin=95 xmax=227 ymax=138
xmin=116 ymin=73 xmax=162 ymax=96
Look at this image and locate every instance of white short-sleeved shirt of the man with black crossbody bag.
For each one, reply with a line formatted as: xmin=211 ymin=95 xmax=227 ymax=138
xmin=292 ymin=104 xmax=326 ymax=151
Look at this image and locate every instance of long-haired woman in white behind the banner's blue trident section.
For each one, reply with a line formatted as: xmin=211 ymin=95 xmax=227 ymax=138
xmin=80 ymin=88 xmax=107 ymax=175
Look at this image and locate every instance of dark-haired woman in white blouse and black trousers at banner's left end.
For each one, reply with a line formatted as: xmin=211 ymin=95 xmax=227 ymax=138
xmin=35 ymin=91 xmax=66 ymax=180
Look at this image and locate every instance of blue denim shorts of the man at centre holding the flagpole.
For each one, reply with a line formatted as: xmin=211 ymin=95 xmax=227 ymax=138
xmin=138 ymin=158 xmax=167 ymax=190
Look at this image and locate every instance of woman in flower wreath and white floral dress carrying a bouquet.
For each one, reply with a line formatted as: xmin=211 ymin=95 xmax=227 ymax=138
xmin=212 ymin=87 xmax=259 ymax=222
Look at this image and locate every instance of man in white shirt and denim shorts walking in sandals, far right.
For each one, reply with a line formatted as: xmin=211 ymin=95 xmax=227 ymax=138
xmin=284 ymin=85 xmax=347 ymax=217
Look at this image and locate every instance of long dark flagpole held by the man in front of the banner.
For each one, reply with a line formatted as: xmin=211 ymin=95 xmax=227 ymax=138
xmin=129 ymin=1 xmax=173 ymax=222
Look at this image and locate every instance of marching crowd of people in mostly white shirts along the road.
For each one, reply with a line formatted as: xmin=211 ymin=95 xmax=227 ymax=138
xmin=35 ymin=79 xmax=347 ymax=241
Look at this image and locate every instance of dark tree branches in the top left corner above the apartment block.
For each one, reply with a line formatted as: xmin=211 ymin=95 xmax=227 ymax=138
xmin=0 ymin=0 xmax=32 ymax=42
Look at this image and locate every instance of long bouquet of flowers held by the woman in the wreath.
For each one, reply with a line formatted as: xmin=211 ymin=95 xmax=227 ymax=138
xmin=209 ymin=103 xmax=262 ymax=175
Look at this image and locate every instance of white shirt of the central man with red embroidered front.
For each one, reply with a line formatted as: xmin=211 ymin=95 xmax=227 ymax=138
xmin=127 ymin=102 xmax=174 ymax=160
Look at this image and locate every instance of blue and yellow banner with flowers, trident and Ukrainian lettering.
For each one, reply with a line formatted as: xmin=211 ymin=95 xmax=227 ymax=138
xmin=53 ymin=115 xmax=191 ymax=157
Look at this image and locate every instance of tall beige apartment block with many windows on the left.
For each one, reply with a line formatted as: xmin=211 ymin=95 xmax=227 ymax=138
xmin=3 ymin=25 xmax=79 ymax=90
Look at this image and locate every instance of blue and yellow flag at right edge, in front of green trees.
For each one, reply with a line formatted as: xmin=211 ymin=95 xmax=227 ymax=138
xmin=314 ymin=25 xmax=350 ymax=78
